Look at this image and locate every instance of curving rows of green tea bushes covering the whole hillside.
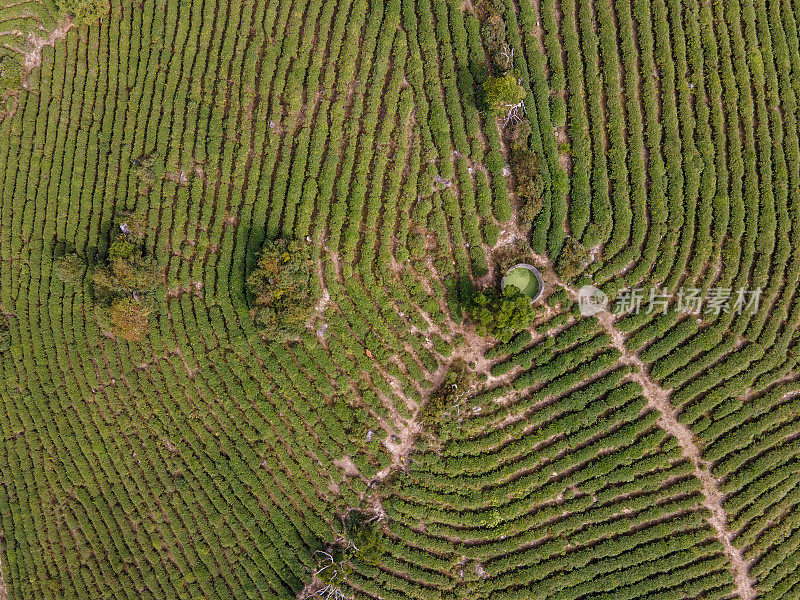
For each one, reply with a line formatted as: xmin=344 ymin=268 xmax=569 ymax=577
xmin=0 ymin=0 xmax=800 ymax=600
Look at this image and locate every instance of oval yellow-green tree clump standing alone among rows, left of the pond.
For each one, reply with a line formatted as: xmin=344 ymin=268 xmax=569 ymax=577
xmin=247 ymin=239 xmax=315 ymax=342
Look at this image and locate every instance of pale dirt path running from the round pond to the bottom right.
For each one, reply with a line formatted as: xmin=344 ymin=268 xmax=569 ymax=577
xmin=536 ymin=255 xmax=756 ymax=600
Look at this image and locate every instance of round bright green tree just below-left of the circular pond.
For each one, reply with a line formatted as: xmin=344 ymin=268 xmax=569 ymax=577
xmin=467 ymin=285 xmax=536 ymax=342
